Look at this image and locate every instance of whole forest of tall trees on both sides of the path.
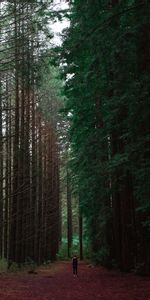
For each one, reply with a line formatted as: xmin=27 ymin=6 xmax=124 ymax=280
xmin=0 ymin=0 xmax=150 ymax=275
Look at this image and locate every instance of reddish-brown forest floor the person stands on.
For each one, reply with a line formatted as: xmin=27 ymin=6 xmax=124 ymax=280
xmin=0 ymin=262 xmax=150 ymax=300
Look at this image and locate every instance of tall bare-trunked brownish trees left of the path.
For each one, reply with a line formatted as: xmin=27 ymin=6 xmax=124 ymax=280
xmin=0 ymin=0 xmax=60 ymax=263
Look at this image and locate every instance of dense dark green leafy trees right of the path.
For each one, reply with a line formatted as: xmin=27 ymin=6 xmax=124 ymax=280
xmin=61 ymin=1 xmax=150 ymax=271
